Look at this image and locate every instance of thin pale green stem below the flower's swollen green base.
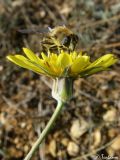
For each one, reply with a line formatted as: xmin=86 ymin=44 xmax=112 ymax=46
xmin=24 ymin=101 xmax=64 ymax=160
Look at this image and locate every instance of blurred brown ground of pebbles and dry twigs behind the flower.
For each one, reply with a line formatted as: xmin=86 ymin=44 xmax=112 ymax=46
xmin=0 ymin=0 xmax=120 ymax=160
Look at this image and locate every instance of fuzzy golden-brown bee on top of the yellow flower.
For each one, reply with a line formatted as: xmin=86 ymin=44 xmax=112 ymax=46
xmin=18 ymin=26 xmax=78 ymax=53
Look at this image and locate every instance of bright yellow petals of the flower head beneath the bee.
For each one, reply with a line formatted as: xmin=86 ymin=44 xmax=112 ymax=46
xmin=7 ymin=48 xmax=117 ymax=78
